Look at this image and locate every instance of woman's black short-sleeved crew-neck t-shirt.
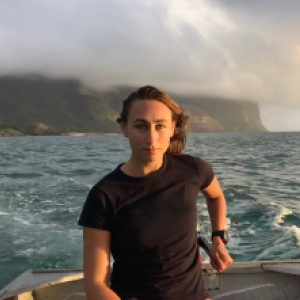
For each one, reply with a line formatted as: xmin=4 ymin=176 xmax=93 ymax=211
xmin=79 ymin=154 xmax=214 ymax=300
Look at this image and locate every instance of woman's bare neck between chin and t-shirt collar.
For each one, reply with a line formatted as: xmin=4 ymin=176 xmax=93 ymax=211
xmin=121 ymin=157 xmax=163 ymax=177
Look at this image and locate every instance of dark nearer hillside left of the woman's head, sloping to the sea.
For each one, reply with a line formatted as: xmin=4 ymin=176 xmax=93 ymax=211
xmin=0 ymin=77 xmax=118 ymax=135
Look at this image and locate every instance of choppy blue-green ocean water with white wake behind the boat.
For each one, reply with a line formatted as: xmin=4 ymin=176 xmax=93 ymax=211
xmin=0 ymin=133 xmax=300 ymax=288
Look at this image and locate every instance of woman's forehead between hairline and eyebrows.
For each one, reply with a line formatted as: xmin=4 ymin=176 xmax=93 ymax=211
xmin=128 ymin=100 xmax=172 ymax=121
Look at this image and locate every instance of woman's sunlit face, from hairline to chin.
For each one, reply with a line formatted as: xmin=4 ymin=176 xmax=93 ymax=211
xmin=121 ymin=100 xmax=175 ymax=164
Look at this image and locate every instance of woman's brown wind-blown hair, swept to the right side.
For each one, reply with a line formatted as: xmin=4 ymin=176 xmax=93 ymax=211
xmin=117 ymin=85 xmax=188 ymax=154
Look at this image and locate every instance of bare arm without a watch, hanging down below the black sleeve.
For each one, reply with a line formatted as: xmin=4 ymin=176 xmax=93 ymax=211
xmin=83 ymin=227 xmax=120 ymax=300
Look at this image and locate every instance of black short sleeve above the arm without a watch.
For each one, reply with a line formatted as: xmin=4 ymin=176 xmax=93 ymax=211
xmin=78 ymin=185 xmax=113 ymax=231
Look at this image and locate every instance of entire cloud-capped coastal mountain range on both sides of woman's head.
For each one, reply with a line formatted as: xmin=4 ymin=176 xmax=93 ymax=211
xmin=0 ymin=76 xmax=266 ymax=135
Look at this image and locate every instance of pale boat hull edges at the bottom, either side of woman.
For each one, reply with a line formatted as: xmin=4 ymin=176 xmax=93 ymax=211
xmin=0 ymin=260 xmax=300 ymax=300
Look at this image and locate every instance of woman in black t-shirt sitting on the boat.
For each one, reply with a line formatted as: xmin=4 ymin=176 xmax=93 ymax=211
xmin=79 ymin=86 xmax=232 ymax=300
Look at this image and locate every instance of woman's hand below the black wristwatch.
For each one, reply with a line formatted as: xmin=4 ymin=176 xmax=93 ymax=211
xmin=210 ymin=237 xmax=233 ymax=272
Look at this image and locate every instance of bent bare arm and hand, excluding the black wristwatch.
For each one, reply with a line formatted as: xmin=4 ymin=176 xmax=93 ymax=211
xmin=202 ymin=177 xmax=233 ymax=271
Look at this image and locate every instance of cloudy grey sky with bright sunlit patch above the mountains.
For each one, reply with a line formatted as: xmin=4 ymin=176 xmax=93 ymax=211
xmin=0 ymin=0 xmax=300 ymax=131
